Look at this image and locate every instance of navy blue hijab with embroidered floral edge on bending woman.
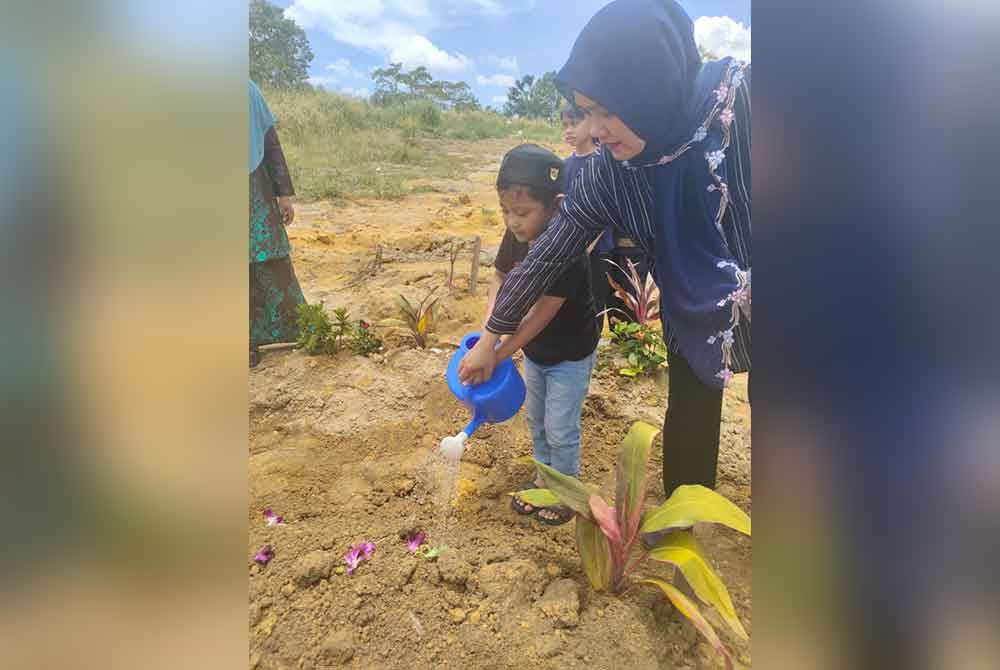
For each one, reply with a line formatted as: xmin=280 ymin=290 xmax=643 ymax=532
xmin=556 ymin=0 xmax=750 ymax=387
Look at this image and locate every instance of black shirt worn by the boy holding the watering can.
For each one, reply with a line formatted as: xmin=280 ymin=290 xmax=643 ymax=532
xmin=494 ymin=231 xmax=600 ymax=365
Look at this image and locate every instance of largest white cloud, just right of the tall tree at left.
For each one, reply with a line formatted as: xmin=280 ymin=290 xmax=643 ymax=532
xmin=285 ymin=0 xmax=478 ymax=76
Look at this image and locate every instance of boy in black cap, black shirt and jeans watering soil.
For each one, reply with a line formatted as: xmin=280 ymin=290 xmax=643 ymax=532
xmin=486 ymin=144 xmax=600 ymax=525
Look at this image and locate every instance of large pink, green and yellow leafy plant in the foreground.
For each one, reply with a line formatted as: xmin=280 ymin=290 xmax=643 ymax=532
xmin=511 ymin=422 xmax=750 ymax=670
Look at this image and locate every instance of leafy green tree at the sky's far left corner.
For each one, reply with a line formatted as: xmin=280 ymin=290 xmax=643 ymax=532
xmin=250 ymin=0 xmax=313 ymax=89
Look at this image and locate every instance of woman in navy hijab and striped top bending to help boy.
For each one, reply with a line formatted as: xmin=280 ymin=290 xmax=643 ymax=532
xmin=460 ymin=0 xmax=750 ymax=496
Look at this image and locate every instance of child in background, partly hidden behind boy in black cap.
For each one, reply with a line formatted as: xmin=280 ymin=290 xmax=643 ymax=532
xmin=559 ymin=103 xmax=615 ymax=331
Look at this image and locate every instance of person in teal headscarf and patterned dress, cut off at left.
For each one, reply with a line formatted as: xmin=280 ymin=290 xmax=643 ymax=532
xmin=250 ymin=81 xmax=305 ymax=367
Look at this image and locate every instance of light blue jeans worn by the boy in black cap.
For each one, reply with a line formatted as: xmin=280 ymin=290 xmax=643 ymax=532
xmin=524 ymin=352 xmax=596 ymax=477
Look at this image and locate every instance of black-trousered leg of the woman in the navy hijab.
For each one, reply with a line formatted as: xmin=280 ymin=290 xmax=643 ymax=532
xmin=663 ymin=353 xmax=722 ymax=497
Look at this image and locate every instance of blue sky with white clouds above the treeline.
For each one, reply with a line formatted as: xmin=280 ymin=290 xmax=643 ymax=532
xmin=274 ymin=0 xmax=750 ymax=107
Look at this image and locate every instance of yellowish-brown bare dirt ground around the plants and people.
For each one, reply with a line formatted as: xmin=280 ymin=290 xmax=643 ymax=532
xmin=248 ymin=135 xmax=752 ymax=670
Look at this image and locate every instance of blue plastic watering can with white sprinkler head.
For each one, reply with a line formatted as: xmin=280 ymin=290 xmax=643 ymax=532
xmin=441 ymin=333 xmax=526 ymax=460
